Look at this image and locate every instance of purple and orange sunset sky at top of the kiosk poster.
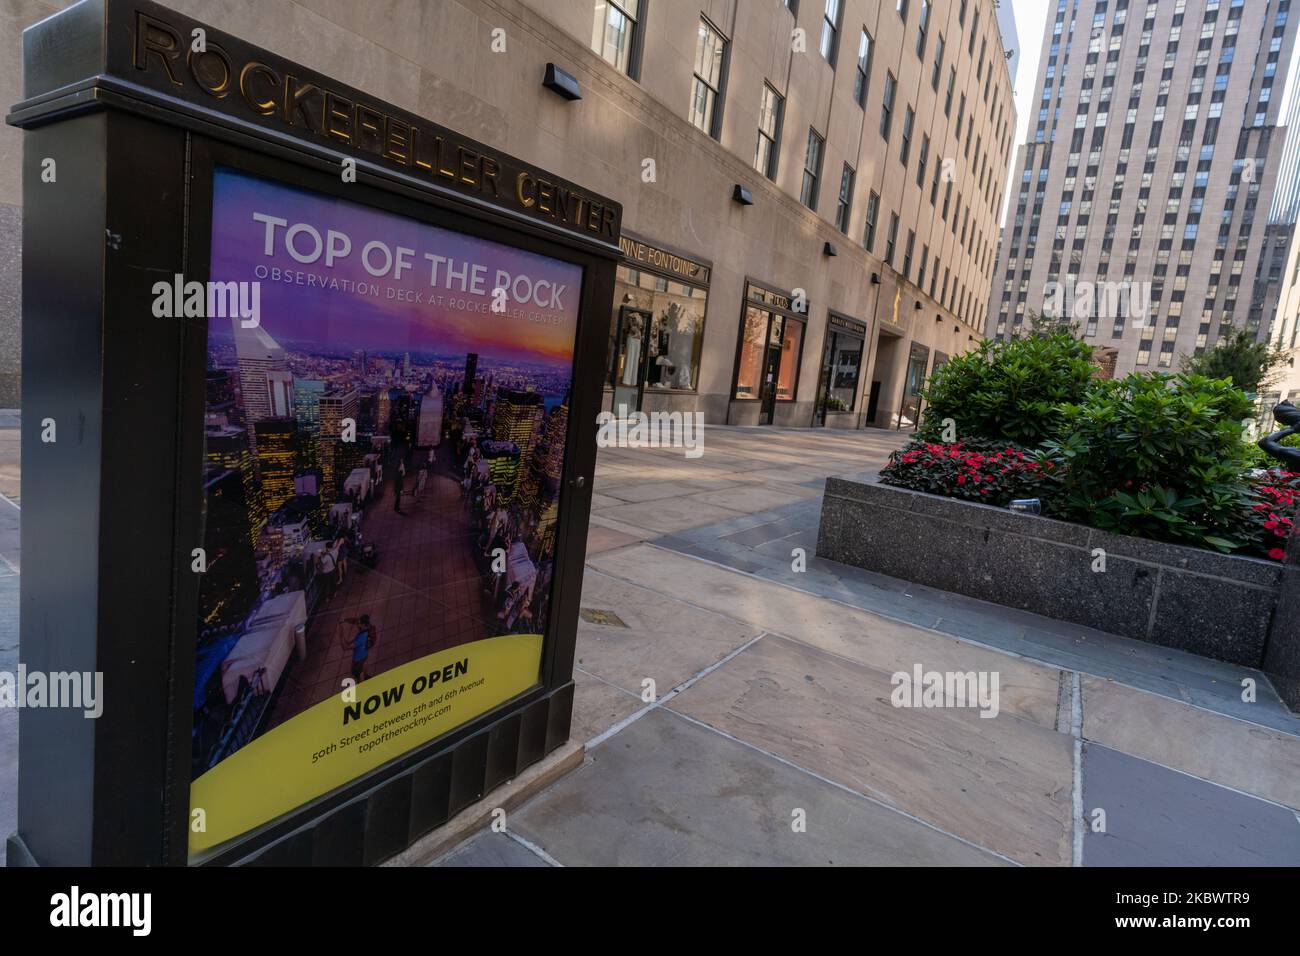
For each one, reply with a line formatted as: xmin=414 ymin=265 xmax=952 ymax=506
xmin=211 ymin=169 xmax=582 ymax=369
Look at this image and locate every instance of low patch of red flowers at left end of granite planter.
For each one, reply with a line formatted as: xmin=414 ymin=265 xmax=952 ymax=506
xmin=880 ymin=440 xmax=1057 ymax=507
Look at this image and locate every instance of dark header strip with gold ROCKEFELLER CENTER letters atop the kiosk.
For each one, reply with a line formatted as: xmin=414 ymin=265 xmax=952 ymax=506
xmin=108 ymin=0 xmax=621 ymax=243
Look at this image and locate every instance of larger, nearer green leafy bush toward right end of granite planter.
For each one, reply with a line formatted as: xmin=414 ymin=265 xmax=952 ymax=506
xmin=1044 ymin=373 xmax=1253 ymax=551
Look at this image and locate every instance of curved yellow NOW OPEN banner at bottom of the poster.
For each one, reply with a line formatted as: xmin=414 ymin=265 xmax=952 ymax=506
xmin=190 ymin=633 xmax=542 ymax=857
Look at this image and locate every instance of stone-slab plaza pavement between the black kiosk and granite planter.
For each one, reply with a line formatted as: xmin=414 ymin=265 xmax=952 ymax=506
xmin=439 ymin=428 xmax=1300 ymax=866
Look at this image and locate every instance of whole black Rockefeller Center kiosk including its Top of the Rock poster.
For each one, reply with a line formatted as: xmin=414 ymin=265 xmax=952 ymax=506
xmin=8 ymin=0 xmax=621 ymax=865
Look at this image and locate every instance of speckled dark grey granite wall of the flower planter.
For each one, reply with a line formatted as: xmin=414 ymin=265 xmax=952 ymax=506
xmin=816 ymin=477 xmax=1284 ymax=671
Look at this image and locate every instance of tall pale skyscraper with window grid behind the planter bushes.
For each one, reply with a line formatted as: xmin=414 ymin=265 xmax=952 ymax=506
xmin=988 ymin=0 xmax=1296 ymax=376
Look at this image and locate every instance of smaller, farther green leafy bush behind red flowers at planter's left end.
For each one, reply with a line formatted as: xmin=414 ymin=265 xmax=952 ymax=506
xmin=919 ymin=329 xmax=1093 ymax=446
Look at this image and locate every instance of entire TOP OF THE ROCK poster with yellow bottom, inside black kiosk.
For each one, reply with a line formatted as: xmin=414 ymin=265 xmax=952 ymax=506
xmin=190 ymin=169 xmax=582 ymax=856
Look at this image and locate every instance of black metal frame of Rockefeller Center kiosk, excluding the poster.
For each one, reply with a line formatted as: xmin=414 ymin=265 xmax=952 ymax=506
xmin=8 ymin=0 xmax=621 ymax=865
